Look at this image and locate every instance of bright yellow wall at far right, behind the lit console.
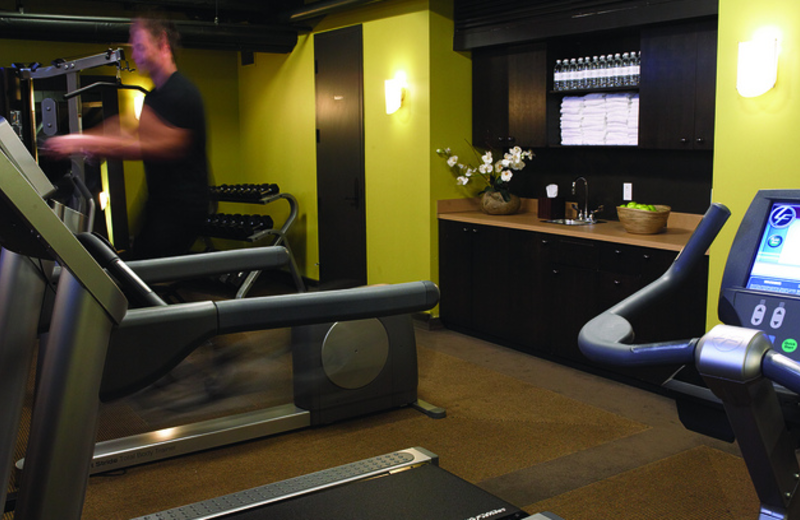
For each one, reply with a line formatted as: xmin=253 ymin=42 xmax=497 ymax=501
xmin=708 ymin=0 xmax=800 ymax=324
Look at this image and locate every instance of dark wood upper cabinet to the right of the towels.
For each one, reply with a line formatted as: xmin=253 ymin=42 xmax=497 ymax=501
xmin=639 ymin=20 xmax=717 ymax=150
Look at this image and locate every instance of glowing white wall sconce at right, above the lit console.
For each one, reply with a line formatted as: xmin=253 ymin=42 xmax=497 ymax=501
xmin=736 ymin=38 xmax=779 ymax=97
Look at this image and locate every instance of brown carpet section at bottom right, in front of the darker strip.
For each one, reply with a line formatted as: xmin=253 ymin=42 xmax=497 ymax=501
xmin=524 ymin=446 xmax=759 ymax=520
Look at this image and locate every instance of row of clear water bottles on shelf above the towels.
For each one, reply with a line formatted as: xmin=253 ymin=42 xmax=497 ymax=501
xmin=553 ymin=51 xmax=642 ymax=92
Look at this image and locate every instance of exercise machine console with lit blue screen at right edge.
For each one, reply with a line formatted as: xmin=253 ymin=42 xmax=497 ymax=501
xmin=719 ymin=190 xmax=800 ymax=360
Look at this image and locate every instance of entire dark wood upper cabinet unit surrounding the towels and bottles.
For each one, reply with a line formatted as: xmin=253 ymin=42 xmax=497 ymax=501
xmin=472 ymin=18 xmax=717 ymax=150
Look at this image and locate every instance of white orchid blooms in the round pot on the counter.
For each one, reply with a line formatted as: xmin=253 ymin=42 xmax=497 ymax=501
xmin=436 ymin=146 xmax=534 ymax=202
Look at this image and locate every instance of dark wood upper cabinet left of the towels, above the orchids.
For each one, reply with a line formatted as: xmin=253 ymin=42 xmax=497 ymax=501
xmin=472 ymin=43 xmax=547 ymax=150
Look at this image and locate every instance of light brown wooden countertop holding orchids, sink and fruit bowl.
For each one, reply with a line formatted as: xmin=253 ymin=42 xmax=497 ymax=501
xmin=437 ymin=199 xmax=703 ymax=251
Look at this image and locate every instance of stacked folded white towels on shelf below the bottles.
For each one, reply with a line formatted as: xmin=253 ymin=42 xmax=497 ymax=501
xmin=561 ymin=93 xmax=639 ymax=146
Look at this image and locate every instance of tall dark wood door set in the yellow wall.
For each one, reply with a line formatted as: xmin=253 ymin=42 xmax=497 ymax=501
xmin=314 ymin=25 xmax=367 ymax=287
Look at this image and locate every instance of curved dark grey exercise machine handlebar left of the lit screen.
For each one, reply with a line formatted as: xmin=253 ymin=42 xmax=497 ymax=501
xmin=578 ymin=203 xmax=731 ymax=366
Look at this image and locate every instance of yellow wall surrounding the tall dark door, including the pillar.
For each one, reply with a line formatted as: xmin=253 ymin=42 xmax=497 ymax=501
xmin=239 ymin=0 xmax=471 ymax=283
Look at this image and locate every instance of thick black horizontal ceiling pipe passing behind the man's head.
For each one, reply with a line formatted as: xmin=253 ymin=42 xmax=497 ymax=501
xmin=0 ymin=13 xmax=297 ymax=53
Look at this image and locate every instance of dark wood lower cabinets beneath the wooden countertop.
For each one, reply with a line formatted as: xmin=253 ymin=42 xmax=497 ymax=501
xmin=439 ymin=220 xmax=708 ymax=385
